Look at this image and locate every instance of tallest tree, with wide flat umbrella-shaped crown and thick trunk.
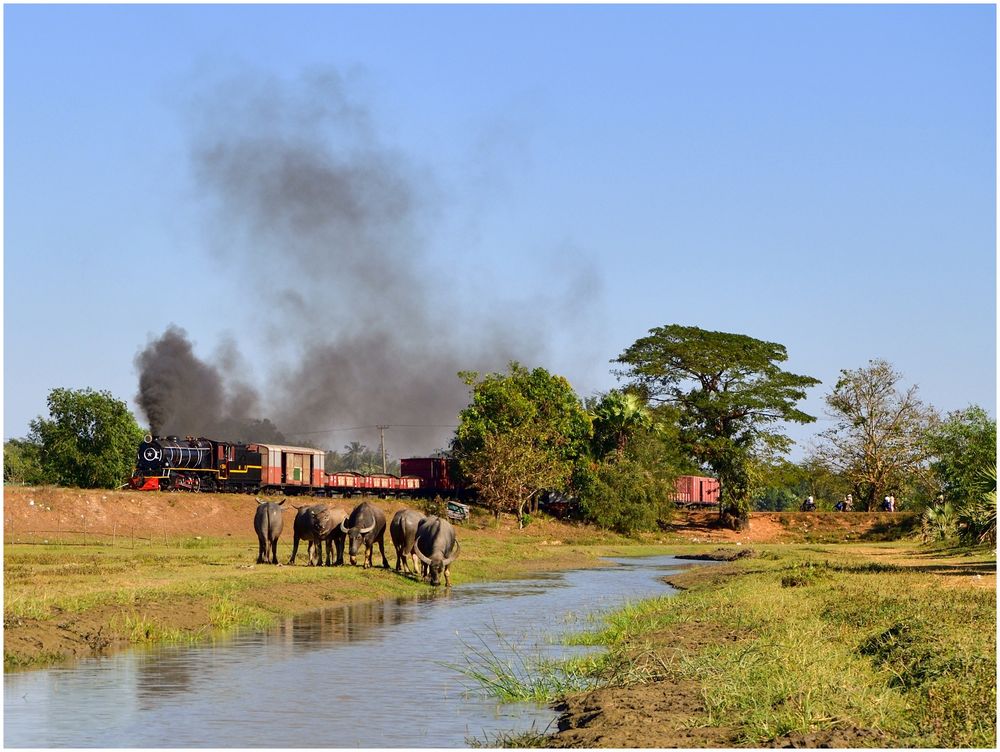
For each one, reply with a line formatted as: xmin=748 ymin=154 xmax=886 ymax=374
xmin=615 ymin=324 xmax=820 ymax=527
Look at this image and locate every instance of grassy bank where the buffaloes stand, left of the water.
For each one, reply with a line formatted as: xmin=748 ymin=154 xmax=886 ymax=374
xmin=4 ymin=525 xmax=621 ymax=670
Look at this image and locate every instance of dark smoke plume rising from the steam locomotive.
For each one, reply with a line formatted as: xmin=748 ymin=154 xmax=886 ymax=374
xmin=136 ymin=72 xmax=596 ymax=456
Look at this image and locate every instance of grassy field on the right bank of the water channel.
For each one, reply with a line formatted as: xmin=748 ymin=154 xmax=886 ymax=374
xmin=544 ymin=543 xmax=996 ymax=748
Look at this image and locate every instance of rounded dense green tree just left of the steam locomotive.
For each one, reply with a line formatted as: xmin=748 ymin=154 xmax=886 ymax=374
xmin=28 ymin=389 xmax=143 ymax=488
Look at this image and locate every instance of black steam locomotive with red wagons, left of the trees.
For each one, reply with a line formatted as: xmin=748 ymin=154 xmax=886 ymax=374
xmin=129 ymin=435 xmax=466 ymax=498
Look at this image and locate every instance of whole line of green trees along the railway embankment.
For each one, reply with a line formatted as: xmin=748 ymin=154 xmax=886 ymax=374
xmin=4 ymin=324 xmax=996 ymax=539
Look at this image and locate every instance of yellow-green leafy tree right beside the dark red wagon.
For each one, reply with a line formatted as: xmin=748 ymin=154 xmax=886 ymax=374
xmin=452 ymin=362 xmax=592 ymax=516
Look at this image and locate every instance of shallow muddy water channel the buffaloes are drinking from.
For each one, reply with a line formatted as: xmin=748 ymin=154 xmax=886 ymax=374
xmin=3 ymin=556 xmax=690 ymax=748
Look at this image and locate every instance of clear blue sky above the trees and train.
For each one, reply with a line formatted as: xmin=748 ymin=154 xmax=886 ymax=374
xmin=3 ymin=5 xmax=996 ymax=462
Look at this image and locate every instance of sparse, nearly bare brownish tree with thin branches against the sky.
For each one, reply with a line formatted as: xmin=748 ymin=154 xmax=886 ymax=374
xmin=815 ymin=359 xmax=937 ymax=511
